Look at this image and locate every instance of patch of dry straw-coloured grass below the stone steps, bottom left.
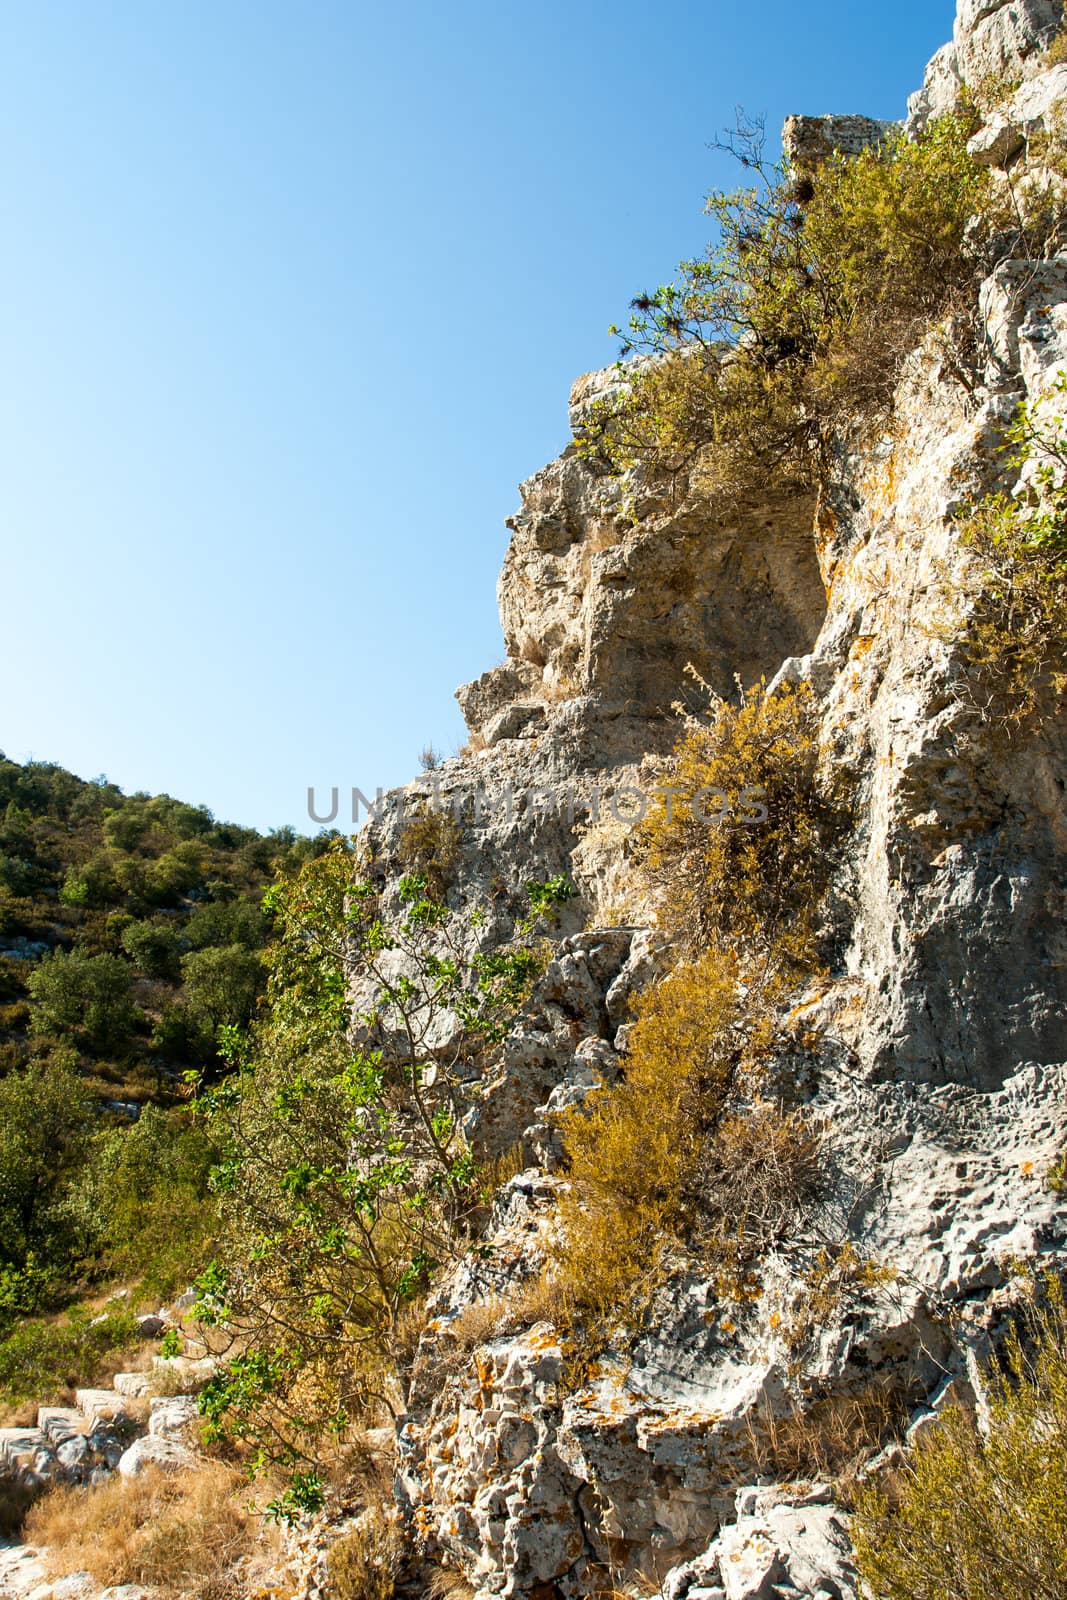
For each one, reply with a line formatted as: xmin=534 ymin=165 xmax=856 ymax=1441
xmin=26 ymin=1464 xmax=256 ymax=1600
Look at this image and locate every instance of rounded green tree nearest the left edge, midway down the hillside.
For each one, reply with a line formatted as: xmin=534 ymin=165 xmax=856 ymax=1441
xmin=27 ymin=949 xmax=136 ymax=1051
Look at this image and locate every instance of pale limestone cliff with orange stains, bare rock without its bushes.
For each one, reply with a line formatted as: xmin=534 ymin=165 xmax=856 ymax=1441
xmin=358 ymin=0 xmax=1067 ymax=1600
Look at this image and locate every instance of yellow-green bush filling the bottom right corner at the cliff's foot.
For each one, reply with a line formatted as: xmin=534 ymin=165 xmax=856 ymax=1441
xmin=853 ymin=1285 xmax=1067 ymax=1600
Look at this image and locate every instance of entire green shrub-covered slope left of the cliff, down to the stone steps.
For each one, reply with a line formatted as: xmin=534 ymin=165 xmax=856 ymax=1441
xmin=0 ymin=757 xmax=323 ymax=1382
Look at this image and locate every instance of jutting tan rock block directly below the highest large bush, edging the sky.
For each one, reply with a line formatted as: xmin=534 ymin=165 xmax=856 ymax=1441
xmin=459 ymin=380 xmax=824 ymax=754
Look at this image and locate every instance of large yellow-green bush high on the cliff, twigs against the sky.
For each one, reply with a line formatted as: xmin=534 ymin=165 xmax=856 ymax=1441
xmin=579 ymin=115 xmax=990 ymax=504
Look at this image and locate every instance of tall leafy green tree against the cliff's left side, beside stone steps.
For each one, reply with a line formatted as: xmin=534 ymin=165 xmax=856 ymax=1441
xmin=192 ymin=843 xmax=556 ymax=1466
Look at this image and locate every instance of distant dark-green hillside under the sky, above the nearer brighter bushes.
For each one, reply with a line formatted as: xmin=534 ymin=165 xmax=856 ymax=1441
xmin=0 ymin=755 xmax=323 ymax=1114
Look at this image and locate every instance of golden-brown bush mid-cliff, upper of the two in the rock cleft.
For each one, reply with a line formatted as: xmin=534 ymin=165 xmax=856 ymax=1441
xmin=638 ymin=685 xmax=846 ymax=974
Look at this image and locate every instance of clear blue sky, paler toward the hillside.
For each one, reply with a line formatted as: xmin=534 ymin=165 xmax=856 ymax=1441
xmin=0 ymin=0 xmax=953 ymax=827
